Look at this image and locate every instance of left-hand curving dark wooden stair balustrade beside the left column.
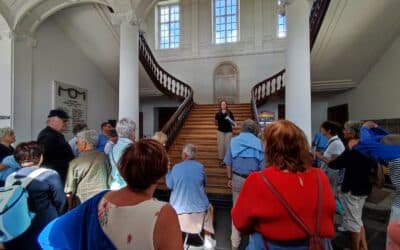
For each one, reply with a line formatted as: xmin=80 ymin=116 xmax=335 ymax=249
xmin=139 ymin=34 xmax=194 ymax=150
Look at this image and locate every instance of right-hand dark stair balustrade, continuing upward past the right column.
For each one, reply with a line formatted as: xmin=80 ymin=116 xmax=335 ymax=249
xmin=251 ymin=0 xmax=331 ymax=122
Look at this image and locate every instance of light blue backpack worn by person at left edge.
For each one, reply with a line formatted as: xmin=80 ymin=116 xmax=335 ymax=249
xmin=0 ymin=168 xmax=48 ymax=242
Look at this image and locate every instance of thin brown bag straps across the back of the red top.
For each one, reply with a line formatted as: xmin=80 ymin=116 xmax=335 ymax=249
xmin=260 ymin=171 xmax=331 ymax=250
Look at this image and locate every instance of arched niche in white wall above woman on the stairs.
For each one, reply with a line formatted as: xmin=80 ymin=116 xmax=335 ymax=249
xmin=214 ymin=62 xmax=239 ymax=103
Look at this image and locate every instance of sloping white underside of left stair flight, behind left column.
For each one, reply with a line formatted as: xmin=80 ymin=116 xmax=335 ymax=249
xmin=53 ymin=4 xmax=161 ymax=96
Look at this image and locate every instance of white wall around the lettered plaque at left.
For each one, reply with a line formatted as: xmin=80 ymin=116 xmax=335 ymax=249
xmin=14 ymin=18 xmax=118 ymax=141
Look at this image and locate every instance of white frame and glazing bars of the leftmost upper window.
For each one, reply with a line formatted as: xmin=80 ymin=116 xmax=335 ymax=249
xmin=155 ymin=1 xmax=182 ymax=50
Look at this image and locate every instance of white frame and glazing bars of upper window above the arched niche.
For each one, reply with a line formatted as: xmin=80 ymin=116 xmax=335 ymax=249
xmin=211 ymin=0 xmax=240 ymax=45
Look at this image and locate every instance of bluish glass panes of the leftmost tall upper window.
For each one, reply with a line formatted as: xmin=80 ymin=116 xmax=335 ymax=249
xmin=159 ymin=4 xmax=180 ymax=49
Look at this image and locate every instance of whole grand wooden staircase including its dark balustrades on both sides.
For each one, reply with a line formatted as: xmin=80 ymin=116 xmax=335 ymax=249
xmin=139 ymin=0 xmax=330 ymax=200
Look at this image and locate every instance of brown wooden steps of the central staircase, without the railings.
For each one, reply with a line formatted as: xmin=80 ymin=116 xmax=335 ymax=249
xmin=160 ymin=103 xmax=252 ymax=194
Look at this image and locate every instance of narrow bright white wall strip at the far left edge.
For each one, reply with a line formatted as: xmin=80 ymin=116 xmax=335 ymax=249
xmin=0 ymin=31 xmax=12 ymax=127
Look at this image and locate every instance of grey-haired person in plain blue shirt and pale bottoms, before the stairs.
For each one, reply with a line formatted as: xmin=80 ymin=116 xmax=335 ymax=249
xmin=166 ymin=144 xmax=215 ymax=249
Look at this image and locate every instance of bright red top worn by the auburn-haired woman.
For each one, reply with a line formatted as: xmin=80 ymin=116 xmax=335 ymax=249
xmin=232 ymin=167 xmax=335 ymax=241
